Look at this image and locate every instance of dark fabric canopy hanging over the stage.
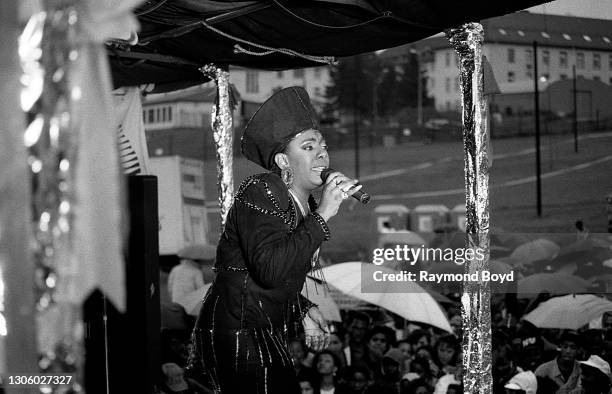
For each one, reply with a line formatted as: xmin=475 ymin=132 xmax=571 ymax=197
xmin=108 ymin=0 xmax=543 ymax=90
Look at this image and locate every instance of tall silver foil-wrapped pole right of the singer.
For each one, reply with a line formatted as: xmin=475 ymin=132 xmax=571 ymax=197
xmin=446 ymin=23 xmax=493 ymax=393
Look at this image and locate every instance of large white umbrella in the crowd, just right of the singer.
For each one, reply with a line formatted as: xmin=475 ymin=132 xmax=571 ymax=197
xmin=314 ymin=262 xmax=452 ymax=332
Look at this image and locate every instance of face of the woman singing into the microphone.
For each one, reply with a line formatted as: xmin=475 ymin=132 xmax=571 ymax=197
xmin=281 ymin=129 xmax=329 ymax=190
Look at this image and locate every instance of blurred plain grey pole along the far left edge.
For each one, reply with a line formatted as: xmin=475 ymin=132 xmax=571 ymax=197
xmin=0 ymin=0 xmax=38 ymax=393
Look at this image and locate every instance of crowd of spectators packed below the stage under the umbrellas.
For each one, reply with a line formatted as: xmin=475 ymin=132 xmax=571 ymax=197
xmin=163 ymin=299 xmax=612 ymax=394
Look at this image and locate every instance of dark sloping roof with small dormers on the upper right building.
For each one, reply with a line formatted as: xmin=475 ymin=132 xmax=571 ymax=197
xmin=378 ymin=11 xmax=612 ymax=60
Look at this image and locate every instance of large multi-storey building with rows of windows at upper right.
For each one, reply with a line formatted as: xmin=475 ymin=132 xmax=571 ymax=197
xmin=380 ymin=11 xmax=612 ymax=115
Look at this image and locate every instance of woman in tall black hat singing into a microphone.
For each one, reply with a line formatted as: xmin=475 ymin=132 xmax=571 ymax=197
xmin=193 ymin=87 xmax=360 ymax=394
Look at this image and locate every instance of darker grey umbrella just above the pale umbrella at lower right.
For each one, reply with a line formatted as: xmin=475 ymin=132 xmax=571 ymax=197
xmin=518 ymin=272 xmax=589 ymax=298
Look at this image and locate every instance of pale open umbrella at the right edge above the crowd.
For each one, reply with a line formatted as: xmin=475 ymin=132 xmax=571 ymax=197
xmin=524 ymin=294 xmax=612 ymax=330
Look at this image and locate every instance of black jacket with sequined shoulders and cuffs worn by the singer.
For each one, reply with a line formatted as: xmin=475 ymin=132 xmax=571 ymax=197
xmin=198 ymin=173 xmax=329 ymax=331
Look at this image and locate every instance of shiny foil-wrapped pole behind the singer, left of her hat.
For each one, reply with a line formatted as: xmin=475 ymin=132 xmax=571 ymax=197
xmin=200 ymin=64 xmax=234 ymax=227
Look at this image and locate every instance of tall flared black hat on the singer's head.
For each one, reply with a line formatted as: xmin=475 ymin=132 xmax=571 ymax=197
xmin=241 ymin=86 xmax=319 ymax=170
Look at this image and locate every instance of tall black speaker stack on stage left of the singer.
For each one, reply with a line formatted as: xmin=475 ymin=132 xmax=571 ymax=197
xmin=83 ymin=175 xmax=161 ymax=393
